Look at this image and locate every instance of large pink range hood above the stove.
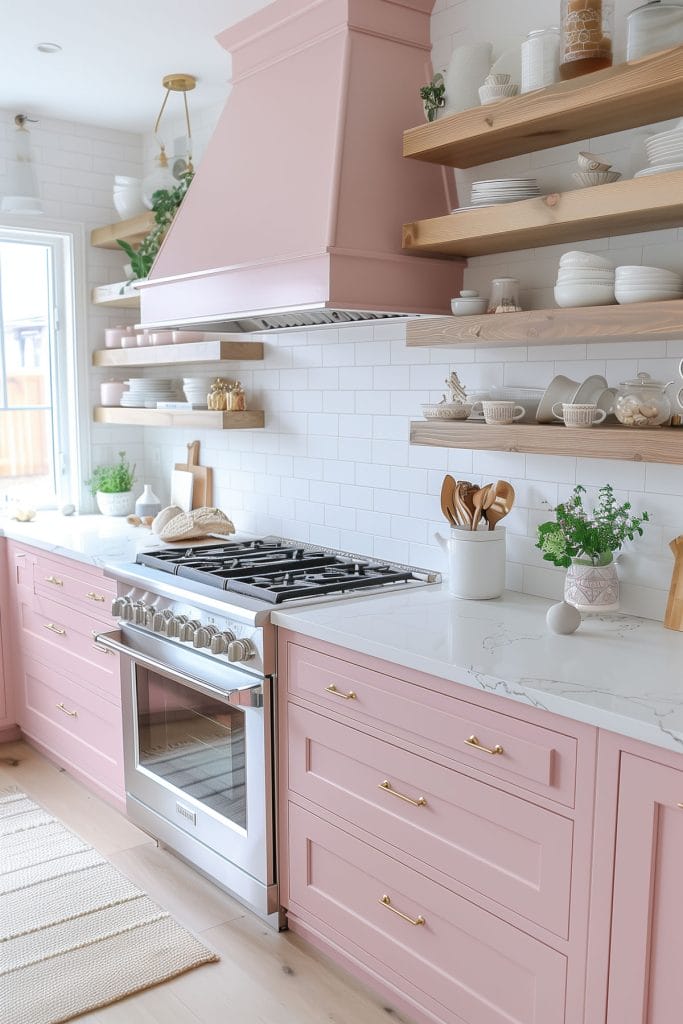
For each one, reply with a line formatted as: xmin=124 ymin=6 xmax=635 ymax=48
xmin=141 ymin=0 xmax=462 ymax=331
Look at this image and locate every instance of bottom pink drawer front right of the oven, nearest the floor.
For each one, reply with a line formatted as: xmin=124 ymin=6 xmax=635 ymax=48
xmin=289 ymin=804 xmax=566 ymax=1024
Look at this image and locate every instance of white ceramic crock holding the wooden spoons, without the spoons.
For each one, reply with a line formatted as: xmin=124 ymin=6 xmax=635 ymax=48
xmin=436 ymin=526 xmax=505 ymax=601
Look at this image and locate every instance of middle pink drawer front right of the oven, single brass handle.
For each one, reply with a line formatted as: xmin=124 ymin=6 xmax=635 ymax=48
xmin=288 ymin=705 xmax=573 ymax=938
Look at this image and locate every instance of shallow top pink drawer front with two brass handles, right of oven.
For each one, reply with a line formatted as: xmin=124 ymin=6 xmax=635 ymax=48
xmin=287 ymin=643 xmax=577 ymax=807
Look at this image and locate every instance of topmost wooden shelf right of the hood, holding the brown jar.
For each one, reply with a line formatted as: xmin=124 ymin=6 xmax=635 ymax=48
xmin=403 ymin=46 xmax=683 ymax=167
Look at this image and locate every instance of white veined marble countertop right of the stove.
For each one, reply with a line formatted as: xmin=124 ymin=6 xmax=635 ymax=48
xmin=272 ymin=586 xmax=683 ymax=753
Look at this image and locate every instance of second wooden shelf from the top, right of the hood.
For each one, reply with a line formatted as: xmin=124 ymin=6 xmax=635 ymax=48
xmin=403 ymin=168 xmax=683 ymax=257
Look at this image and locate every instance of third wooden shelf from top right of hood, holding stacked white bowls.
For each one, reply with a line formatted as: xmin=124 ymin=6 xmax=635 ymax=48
xmin=405 ymin=299 xmax=683 ymax=348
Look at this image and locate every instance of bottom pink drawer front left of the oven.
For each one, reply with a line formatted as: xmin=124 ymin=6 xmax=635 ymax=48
xmin=19 ymin=659 xmax=124 ymax=797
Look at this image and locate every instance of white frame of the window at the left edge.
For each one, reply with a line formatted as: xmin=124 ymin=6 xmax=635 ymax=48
xmin=0 ymin=215 xmax=91 ymax=511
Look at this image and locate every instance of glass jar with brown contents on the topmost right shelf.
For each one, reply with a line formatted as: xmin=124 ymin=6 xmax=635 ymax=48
xmin=560 ymin=0 xmax=612 ymax=81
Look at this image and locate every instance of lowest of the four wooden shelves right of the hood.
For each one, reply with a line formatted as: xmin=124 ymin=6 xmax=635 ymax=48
xmin=411 ymin=420 xmax=683 ymax=464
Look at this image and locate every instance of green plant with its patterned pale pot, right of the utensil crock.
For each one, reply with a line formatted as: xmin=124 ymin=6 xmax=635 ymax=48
xmin=537 ymin=483 xmax=649 ymax=611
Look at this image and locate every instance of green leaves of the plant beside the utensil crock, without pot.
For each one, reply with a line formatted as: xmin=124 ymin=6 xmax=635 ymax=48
xmin=536 ymin=483 xmax=649 ymax=568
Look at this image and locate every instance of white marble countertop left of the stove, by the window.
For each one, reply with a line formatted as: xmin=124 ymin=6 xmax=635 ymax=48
xmin=0 ymin=512 xmax=162 ymax=568
